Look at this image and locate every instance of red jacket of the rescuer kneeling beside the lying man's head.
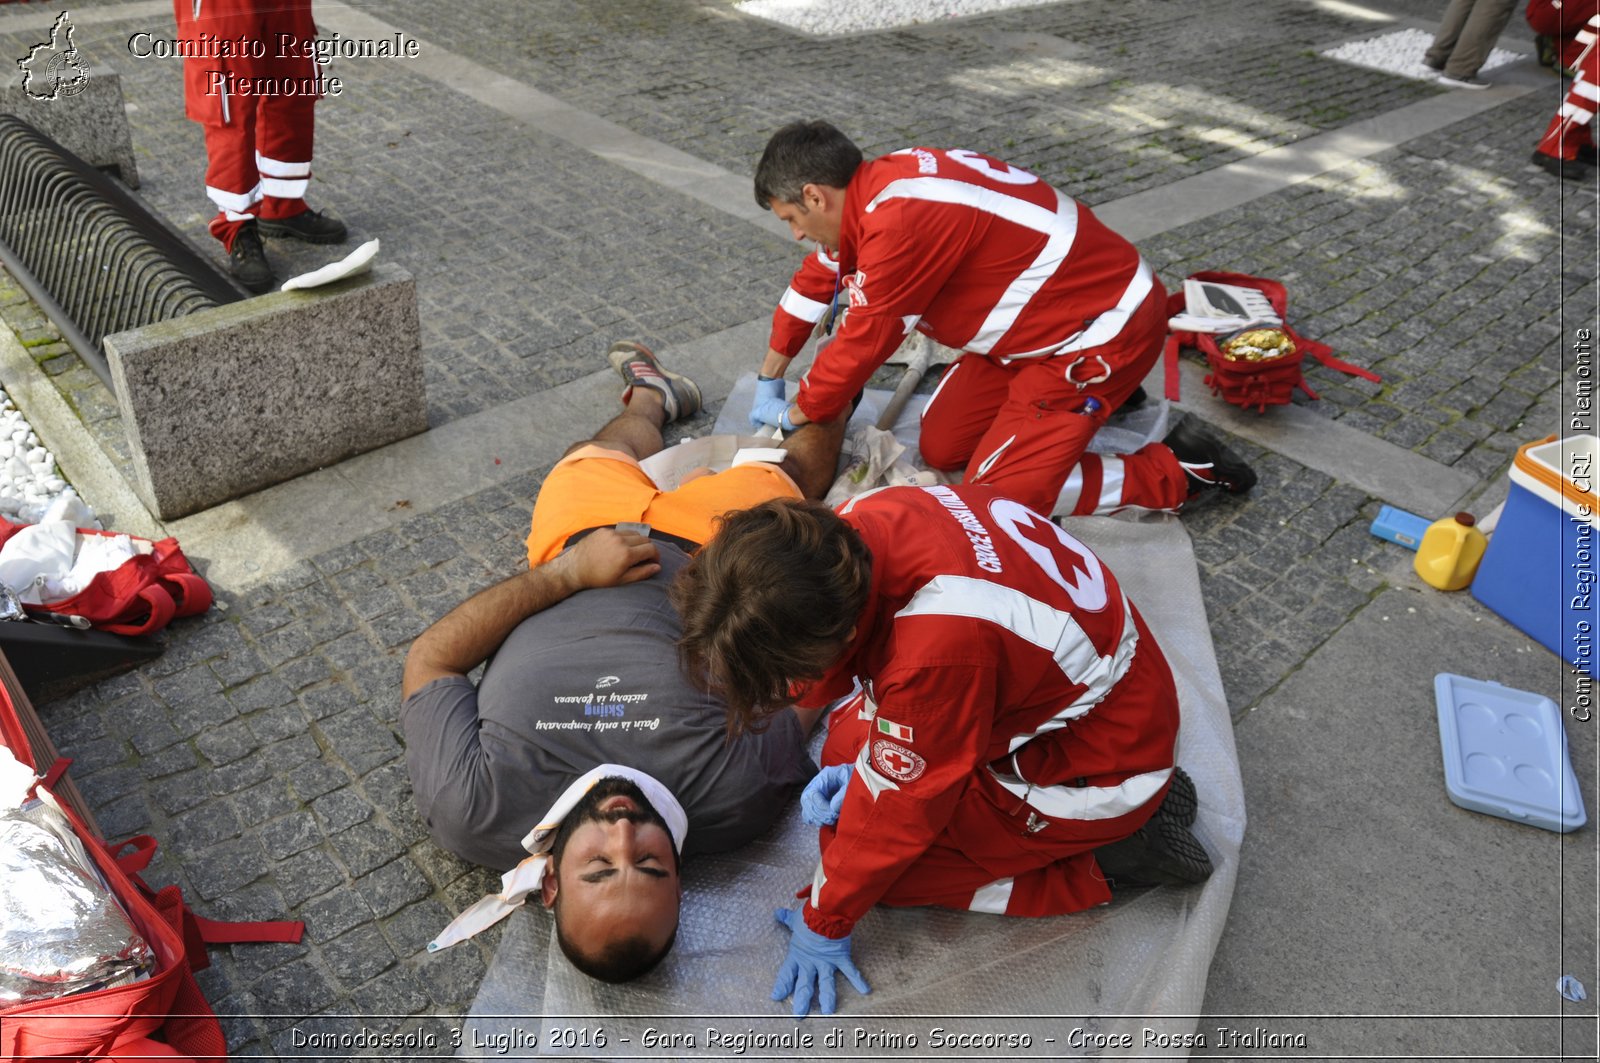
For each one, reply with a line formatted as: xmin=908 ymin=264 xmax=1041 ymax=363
xmin=805 ymin=487 xmax=1178 ymax=938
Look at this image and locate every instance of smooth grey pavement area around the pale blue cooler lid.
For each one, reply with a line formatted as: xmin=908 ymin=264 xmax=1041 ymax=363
xmin=1202 ymin=589 xmax=1595 ymax=1057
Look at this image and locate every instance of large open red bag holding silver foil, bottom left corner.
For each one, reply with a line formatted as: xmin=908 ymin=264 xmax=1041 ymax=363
xmin=0 ymin=684 xmax=306 ymax=1063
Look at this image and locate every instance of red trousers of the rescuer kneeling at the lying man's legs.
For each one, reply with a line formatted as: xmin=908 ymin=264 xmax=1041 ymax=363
xmin=920 ymin=280 xmax=1189 ymax=515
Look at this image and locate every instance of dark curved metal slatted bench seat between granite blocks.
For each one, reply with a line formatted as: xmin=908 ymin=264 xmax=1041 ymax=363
xmin=0 ymin=115 xmax=246 ymax=387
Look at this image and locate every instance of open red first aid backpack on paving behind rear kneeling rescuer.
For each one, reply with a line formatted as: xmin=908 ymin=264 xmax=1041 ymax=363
xmin=1163 ymin=271 xmax=1381 ymax=413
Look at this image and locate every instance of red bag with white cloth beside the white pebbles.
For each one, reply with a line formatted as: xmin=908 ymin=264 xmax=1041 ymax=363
xmin=0 ymin=517 xmax=213 ymax=636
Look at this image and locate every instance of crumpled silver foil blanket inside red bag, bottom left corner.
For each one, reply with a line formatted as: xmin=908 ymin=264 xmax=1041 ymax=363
xmin=0 ymin=800 xmax=155 ymax=1005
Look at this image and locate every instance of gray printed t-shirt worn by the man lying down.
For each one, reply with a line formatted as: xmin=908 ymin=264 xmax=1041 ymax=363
xmin=400 ymin=543 xmax=816 ymax=871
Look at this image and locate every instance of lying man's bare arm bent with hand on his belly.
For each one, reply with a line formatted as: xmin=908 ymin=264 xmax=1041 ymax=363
xmin=400 ymin=528 xmax=661 ymax=698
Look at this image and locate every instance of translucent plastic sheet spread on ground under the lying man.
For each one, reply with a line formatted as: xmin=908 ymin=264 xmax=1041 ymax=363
xmin=459 ymin=378 xmax=1245 ymax=1060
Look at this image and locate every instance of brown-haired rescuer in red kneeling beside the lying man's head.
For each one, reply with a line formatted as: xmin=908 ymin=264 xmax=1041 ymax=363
xmin=672 ymin=485 xmax=1211 ymax=1015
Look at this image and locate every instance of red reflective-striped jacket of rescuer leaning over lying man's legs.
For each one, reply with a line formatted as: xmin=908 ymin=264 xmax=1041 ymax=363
xmin=771 ymin=147 xmax=1152 ymax=419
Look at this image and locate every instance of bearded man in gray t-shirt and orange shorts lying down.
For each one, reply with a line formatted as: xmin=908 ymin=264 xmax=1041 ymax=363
xmin=400 ymin=343 xmax=843 ymax=981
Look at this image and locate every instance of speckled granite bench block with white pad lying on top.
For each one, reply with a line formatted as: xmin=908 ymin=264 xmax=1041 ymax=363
xmin=106 ymin=266 xmax=427 ymax=515
